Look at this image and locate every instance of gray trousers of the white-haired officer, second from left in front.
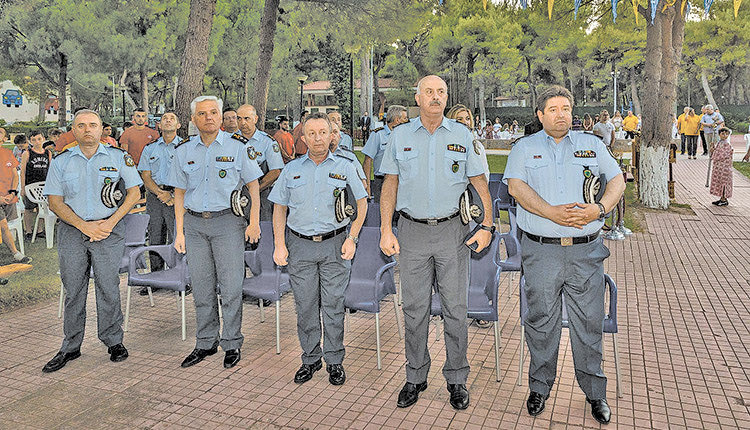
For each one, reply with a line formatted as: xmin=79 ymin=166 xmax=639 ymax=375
xmin=184 ymin=213 xmax=247 ymax=351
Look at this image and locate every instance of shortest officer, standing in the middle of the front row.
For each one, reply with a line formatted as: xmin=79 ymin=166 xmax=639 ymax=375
xmin=269 ymin=113 xmax=367 ymax=385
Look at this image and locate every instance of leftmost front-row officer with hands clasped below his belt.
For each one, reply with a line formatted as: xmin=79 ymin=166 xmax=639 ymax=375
xmin=42 ymin=109 xmax=142 ymax=373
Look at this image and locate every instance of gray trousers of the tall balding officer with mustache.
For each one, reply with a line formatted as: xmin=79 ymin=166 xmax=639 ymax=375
xmin=398 ymin=217 xmax=470 ymax=384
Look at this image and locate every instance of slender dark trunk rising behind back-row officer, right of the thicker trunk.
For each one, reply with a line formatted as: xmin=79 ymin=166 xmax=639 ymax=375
xmin=253 ymin=0 xmax=280 ymax=130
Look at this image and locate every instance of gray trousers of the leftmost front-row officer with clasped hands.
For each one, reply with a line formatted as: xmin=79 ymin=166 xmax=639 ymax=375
xmin=56 ymin=221 xmax=125 ymax=352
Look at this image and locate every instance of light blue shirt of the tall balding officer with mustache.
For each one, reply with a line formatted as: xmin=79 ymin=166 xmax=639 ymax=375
xmin=380 ymin=117 xmax=484 ymax=219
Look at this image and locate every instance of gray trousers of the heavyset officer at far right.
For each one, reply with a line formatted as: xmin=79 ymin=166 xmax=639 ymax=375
xmin=521 ymin=235 xmax=609 ymax=400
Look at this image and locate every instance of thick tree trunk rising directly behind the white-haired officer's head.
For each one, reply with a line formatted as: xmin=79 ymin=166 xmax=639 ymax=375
xmin=176 ymin=0 xmax=216 ymax=136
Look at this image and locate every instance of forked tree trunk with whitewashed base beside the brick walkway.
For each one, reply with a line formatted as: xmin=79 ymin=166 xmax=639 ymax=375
xmin=638 ymin=0 xmax=685 ymax=209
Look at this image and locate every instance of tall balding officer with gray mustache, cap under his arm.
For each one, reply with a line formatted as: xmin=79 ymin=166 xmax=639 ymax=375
xmin=380 ymin=76 xmax=493 ymax=409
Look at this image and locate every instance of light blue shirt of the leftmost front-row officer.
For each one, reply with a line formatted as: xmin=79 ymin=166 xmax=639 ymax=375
xmin=44 ymin=143 xmax=143 ymax=221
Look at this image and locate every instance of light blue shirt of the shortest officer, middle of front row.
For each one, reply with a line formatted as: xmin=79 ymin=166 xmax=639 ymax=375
xmin=268 ymin=151 xmax=367 ymax=236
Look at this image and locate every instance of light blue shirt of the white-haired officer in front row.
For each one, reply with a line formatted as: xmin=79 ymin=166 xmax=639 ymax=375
xmin=167 ymin=131 xmax=263 ymax=212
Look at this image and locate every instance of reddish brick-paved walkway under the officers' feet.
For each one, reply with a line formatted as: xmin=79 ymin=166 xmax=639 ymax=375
xmin=0 ymin=157 xmax=750 ymax=429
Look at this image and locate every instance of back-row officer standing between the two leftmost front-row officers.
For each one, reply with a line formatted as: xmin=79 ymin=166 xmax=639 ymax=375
xmin=138 ymin=112 xmax=182 ymax=278
